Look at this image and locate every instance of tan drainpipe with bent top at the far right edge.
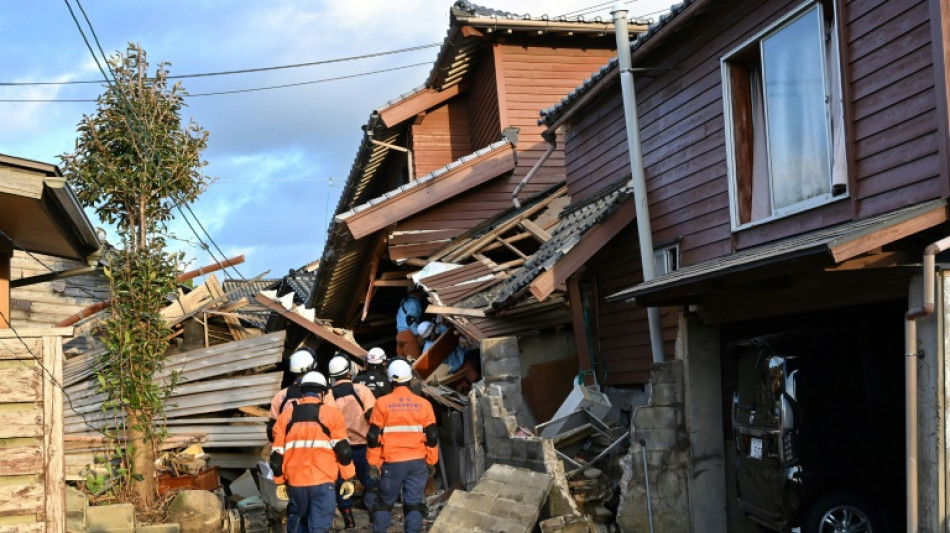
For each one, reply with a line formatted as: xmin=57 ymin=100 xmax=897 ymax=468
xmin=904 ymin=237 xmax=950 ymax=533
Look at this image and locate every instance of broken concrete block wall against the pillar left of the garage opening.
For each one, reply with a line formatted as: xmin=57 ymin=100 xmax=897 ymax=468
xmin=617 ymin=360 xmax=691 ymax=533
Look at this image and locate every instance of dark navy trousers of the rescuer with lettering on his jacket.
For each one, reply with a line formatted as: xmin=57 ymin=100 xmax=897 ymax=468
xmin=373 ymin=459 xmax=429 ymax=533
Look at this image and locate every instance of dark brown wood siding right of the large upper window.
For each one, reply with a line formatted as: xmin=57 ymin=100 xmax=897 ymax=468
xmin=845 ymin=0 xmax=946 ymax=218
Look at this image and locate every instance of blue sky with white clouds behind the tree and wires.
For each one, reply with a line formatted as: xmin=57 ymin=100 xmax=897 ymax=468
xmin=0 ymin=0 xmax=675 ymax=278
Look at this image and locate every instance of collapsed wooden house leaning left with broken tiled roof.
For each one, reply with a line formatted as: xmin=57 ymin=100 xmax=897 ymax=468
xmin=312 ymin=1 xmax=645 ymax=364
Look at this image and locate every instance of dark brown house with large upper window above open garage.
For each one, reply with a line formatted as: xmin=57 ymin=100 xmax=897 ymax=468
xmin=542 ymin=0 xmax=950 ymax=531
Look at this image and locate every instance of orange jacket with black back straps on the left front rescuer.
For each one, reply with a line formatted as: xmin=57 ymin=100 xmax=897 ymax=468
xmin=273 ymin=396 xmax=356 ymax=487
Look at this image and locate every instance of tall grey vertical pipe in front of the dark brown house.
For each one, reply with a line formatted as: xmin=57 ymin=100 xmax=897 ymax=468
xmin=610 ymin=4 xmax=663 ymax=363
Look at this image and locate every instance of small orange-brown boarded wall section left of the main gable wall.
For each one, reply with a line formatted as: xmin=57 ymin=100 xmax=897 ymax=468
xmin=412 ymin=100 xmax=471 ymax=177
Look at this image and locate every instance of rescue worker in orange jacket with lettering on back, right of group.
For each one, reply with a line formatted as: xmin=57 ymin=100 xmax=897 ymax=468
xmin=366 ymin=359 xmax=439 ymax=533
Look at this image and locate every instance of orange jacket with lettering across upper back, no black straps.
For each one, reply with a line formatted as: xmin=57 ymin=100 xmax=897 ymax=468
xmin=366 ymin=386 xmax=439 ymax=467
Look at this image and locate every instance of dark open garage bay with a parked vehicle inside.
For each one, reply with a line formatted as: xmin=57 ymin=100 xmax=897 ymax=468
xmin=730 ymin=310 xmax=904 ymax=533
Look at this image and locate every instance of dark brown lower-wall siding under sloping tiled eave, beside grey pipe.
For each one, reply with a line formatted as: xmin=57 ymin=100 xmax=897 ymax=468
xmin=571 ymin=224 xmax=677 ymax=386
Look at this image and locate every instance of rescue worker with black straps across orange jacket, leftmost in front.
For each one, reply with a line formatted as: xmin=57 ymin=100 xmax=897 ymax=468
xmin=270 ymin=372 xmax=356 ymax=533
